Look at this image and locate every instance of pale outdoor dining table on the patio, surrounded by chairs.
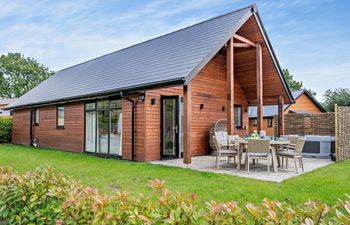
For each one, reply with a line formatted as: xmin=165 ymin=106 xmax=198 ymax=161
xmin=229 ymin=139 xmax=290 ymax=173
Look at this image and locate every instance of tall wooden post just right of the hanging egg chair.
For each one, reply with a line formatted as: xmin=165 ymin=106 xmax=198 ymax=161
xmin=226 ymin=38 xmax=235 ymax=135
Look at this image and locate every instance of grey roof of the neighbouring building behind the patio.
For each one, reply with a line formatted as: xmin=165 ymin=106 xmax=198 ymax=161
xmin=249 ymin=89 xmax=325 ymax=118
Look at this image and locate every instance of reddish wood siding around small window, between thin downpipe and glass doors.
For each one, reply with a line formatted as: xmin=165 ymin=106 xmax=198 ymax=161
xmin=28 ymin=102 xmax=84 ymax=152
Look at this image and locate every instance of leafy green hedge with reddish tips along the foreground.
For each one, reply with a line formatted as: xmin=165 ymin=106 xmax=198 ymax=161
xmin=0 ymin=168 xmax=350 ymax=225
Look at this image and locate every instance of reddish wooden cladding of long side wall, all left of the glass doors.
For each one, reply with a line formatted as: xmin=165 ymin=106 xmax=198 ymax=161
xmin=12 ymin=102 xmax=84 ymax=152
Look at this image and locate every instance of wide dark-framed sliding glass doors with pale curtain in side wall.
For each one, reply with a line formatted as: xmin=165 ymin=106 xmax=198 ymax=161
xmin=85 ymin=99 xmax=122 ymax=156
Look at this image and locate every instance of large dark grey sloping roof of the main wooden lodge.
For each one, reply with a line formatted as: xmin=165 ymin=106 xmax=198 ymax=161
xmin=8 ymin=5 xmax=256 ymax=108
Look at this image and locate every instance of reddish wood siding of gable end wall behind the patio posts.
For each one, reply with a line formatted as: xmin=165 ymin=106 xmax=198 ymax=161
xmin=191 ymin=54 xmax=249 ymax=155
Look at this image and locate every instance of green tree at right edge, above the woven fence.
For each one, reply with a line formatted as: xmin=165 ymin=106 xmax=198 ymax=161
xmin=323 ymin=88 xmax=350 ymax=112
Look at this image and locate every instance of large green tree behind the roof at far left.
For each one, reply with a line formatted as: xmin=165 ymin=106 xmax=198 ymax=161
xmin=0 ymin=53 xmax=54 ymax=98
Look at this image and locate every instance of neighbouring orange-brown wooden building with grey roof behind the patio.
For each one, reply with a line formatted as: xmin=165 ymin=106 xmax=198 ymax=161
xmin=249 ymin=89 xmax=326 ymax=135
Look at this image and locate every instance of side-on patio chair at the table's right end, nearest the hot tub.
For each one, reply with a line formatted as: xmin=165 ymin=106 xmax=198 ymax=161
xmin=277 ymin=138 xmax=305 ymax=174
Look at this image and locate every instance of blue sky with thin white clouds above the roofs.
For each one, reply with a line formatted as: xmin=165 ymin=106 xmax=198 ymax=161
xmin=0 ymin=0 xmax=350 ymax=100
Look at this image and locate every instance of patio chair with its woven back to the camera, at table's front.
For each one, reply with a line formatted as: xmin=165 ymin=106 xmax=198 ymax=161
xmin=246 ymin=139 xmax=272 ymax=174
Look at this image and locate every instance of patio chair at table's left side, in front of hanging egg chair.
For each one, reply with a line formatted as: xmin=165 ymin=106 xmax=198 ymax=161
xmin=213 ymin=132 xmax=238 ymax=169
